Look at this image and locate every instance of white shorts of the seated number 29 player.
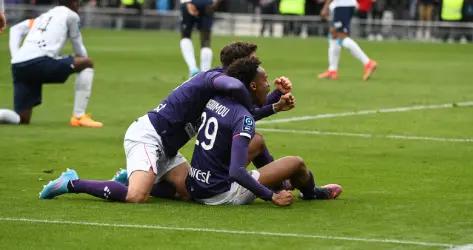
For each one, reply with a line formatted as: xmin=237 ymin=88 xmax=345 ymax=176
xmin=197 ymin=170 xmax=260 ymax=205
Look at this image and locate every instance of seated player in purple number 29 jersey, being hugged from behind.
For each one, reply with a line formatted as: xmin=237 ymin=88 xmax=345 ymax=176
xmin=186 ymin=57 xmax=342 ymax=206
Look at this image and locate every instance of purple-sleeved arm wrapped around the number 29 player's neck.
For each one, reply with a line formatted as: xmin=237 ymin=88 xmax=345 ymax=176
xmin=213 ymin=74 xmax=252 ymax=110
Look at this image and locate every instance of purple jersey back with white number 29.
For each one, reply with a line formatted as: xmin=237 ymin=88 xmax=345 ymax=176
xmin=187 ymin=96 xmax=254 ymax=199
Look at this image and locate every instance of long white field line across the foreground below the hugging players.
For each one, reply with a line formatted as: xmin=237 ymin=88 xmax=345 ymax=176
xmin=0 ymin=217 xmax=457 ymax=248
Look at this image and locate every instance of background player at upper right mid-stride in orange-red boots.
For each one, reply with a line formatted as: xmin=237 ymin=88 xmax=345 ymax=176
xmin=318 ymin=0 xmax=377 ymax=80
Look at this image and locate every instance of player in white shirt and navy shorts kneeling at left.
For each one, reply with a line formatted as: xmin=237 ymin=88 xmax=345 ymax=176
xmin=0 ymin=0 xmax=103 ymax=128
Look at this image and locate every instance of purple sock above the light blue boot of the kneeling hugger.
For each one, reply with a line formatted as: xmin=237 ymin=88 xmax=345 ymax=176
xmin=68 ymin=180 xmax=128 ymax=201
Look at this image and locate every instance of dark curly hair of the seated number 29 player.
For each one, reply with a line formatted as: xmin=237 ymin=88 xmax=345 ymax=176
xmin=225 ymin=57 xmax=261 ymax=88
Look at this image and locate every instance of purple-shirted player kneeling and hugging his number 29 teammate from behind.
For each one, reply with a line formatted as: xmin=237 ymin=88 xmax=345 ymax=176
xmin=40 ymin=44 xmax=296 ymax=202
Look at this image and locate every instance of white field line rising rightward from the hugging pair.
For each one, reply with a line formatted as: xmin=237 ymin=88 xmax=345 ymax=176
xmin=258 ymin=101 xmax=473 ymax=124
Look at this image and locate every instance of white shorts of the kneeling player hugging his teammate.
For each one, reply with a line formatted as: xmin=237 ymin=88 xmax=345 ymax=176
xmin=123 ymin=115 xmax=186 ymax=183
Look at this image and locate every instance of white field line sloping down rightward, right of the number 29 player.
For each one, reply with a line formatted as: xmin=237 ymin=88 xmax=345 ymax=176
xmin=257 ymin=128 xmax=473 ymax=143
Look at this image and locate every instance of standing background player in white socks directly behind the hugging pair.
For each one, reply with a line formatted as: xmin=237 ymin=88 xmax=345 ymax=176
xmin=180 ymin=0 xmax=223 ymax=77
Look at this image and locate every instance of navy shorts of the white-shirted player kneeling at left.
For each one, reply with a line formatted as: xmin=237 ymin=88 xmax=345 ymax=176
xmin=12 ymin=56 xmax=74 ymax=113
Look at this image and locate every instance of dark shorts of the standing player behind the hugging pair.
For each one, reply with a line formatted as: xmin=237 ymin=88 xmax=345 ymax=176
xmin=181 ymin=4 xmax=213 ymax=36
